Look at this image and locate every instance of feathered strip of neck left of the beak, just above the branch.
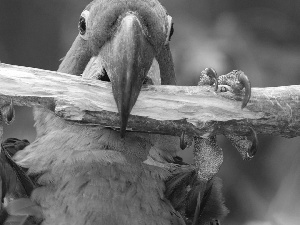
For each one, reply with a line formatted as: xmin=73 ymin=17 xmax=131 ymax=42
xmin=57 ymin=36 xmax=91 ymax=76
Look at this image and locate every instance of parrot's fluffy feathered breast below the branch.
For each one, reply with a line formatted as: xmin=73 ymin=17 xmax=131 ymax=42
xmin=15 ymin=108 xmax=183 ymax=224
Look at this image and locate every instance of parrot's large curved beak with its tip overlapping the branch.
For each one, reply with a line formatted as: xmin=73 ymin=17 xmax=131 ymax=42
xmin=93 ymin=13 xmax=154 ymax=137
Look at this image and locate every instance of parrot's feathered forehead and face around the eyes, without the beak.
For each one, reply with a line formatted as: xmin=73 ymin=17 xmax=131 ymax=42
xmin=79 ymin=0 xmax=173 ymax=55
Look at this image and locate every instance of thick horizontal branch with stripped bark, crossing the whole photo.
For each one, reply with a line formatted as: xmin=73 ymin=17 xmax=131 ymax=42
xmin=0 ymin=64 xmax=300 ymax=137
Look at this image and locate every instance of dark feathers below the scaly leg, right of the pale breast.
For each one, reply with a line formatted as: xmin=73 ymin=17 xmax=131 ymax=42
xmin=165 ymin=170 xmax=228 ymax=225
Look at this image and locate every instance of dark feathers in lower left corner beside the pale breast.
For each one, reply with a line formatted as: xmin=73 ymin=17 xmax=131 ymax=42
xmin=0 ymin=138 xmax=43 ymax=225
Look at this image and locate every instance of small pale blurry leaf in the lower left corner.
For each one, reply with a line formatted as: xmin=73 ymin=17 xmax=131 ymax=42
xmin=6 ymin=198 xmax=43 ymax=218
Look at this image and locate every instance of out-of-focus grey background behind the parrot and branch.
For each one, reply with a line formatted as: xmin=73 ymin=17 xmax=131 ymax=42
xmin=0 ymin=0 xmax=300 ymax=225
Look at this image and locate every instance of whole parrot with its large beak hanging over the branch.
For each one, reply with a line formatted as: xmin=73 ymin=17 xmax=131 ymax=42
xmin=9 ymin=0 xmax=258 ymax=225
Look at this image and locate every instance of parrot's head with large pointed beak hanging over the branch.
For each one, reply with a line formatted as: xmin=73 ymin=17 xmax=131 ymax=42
xmin=58 ymin=0 xmax=175 ymax=136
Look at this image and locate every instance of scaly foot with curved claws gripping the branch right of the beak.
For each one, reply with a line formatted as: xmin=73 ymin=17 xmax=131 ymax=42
xmin=180 ymin=68 xmax=258 ymax=164
